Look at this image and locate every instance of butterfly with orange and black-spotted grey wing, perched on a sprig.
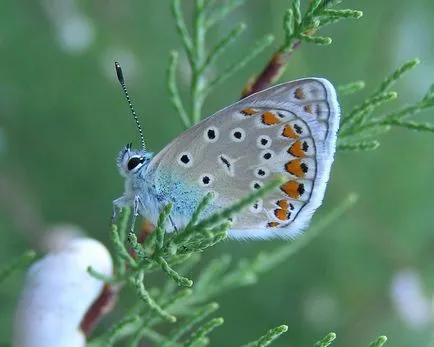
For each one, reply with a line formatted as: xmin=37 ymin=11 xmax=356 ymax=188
xmin=113 ymin=64 xmax=340 ymax=239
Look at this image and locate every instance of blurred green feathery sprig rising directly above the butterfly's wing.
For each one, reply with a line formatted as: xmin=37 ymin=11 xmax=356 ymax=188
xmin=168 ymin=0 xmax=273 ymax=127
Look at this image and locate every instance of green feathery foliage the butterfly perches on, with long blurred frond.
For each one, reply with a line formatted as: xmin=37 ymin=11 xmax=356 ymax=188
xmin=89 ymin=188 xmax=357 ymax=347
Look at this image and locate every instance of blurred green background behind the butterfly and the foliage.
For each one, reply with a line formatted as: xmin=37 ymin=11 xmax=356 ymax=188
xmin=0 ymin=0 xmax=434 ymax=347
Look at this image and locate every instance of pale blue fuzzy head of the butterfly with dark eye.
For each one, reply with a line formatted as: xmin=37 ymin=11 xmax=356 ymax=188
xmin=117 ymin=144 xmax=152 ymax=177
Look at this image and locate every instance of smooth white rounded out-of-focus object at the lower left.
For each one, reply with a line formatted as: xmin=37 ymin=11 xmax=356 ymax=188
xmin=12 ymin=238 xmax=113 ymax=347
